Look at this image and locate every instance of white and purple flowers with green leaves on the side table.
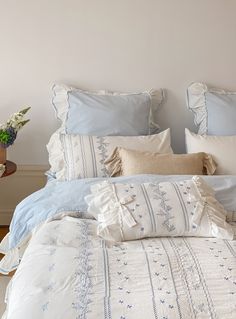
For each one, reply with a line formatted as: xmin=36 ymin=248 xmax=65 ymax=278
xmin=0 ymin=107 xmax=30 ymax=148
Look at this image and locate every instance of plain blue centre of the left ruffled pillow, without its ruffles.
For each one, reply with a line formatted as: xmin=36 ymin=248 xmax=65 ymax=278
xmin=66 ymin=91 xmax=151 ymax=136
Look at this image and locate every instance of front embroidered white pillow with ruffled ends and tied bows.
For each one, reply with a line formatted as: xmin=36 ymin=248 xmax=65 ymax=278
xmin=86 ymin=176 xmax=233 ymax=241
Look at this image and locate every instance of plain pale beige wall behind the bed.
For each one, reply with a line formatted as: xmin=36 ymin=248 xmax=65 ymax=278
xmin=0 ymin=0 xmax=236 ymax=165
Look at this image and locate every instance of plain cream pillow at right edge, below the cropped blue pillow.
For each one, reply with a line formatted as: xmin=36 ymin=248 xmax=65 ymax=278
xmin=185 ymin=129 xmax=236 ymax=175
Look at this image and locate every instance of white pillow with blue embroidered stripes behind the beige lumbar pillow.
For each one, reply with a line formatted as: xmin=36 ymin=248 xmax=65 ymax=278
xmin=47 ymin=129 xmax=173 ymax=180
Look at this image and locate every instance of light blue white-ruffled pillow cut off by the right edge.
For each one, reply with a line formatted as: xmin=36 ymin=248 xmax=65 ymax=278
xmin=187 ymin=83 xmax=236 ymax=136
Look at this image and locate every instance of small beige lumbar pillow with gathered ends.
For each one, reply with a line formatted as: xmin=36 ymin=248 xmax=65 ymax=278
xmin=105 ymin=147 xmax=216 ymax=177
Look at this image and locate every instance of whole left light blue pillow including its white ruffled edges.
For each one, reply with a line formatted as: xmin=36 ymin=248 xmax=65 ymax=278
xmin=53 ymin=85 xmax=163 ymax=136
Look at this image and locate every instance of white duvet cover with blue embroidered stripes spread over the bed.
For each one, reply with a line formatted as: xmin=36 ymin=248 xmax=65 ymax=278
xmin=4 ymin=217 xmax=236 ymax=319
